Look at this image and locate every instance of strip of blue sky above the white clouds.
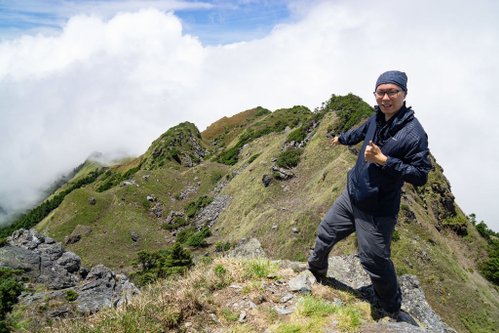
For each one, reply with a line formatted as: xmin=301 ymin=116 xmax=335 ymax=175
xmin=0 ymin=0 xmax=292 ymax=45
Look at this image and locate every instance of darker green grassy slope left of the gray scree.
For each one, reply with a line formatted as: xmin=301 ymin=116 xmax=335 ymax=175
xmin=37 ymin=162 xmax=230 ymax=271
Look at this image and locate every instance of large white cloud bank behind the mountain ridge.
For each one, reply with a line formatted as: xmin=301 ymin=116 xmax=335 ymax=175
xmin=0 ymin=1 xmax=499 ymax=230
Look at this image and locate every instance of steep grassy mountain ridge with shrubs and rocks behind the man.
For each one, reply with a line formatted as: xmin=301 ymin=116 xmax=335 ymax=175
xmin=1 ymin=94 xmax=499 ymax=332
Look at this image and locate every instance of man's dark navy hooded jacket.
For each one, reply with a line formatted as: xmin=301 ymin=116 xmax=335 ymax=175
xmin=339 ymin=103 xmax=431 ymax=216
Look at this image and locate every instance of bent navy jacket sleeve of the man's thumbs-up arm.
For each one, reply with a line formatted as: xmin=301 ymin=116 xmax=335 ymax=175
xmin=382 ymin=134 xmax=431 ymax=186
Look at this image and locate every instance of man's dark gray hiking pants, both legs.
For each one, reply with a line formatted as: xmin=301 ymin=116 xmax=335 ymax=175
xmin=308 ymin=190 xmax=402 ymax=312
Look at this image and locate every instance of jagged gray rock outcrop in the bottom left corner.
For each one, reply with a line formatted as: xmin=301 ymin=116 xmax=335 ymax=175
xmin=0 ymin=229 xmax=139 ymax=321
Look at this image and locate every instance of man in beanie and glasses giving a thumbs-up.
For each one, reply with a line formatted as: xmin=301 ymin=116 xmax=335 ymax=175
xmin=308 ymin=71 xmax=431 ymax=319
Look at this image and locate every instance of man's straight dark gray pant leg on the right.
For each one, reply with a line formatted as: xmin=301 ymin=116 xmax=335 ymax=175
xmin=354 ymin=207 xmax=402 ymax=312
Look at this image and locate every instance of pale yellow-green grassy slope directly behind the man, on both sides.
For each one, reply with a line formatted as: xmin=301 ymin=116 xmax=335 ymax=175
xmin=213 ymin=114 xmax=499 ymax=332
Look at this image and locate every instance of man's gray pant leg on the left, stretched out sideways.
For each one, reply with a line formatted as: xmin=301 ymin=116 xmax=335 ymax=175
xmin=308 ymin=190 xmax=355 ymax=271
